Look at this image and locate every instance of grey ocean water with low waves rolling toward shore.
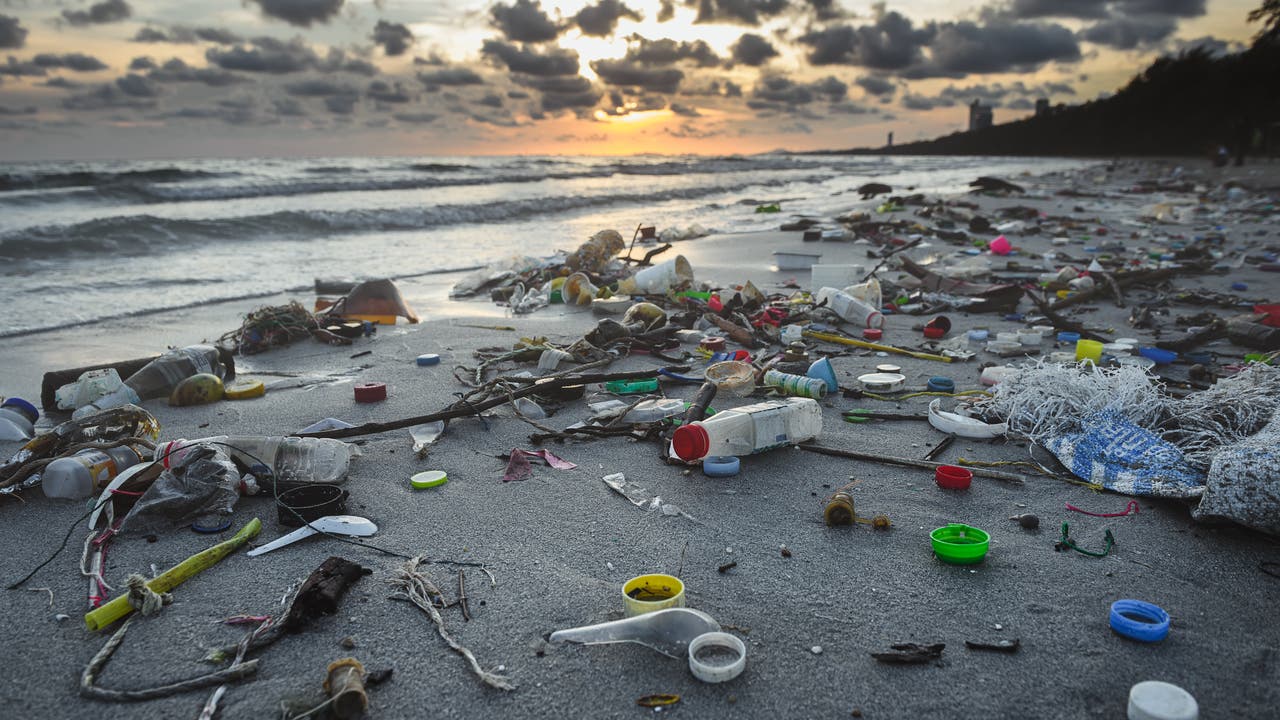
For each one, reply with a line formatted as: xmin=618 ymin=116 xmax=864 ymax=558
xmin=0 ymin=154 xmax=1085 ymax=337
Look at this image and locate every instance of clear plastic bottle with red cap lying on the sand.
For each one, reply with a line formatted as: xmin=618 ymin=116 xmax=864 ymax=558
xmin=672 ymin=397 xmax=822 ymax=461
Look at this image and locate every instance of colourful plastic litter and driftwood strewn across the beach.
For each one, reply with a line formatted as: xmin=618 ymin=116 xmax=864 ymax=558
xmin=0 ymin=166 xmax=1280 ymax=717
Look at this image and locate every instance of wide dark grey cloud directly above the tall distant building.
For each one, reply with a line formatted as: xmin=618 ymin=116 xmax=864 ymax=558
xmin=929 ymin=22 xmax=1080 ymax=74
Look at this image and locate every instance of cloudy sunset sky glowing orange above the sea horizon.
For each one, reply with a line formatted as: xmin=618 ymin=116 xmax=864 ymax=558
xmin=0 ymin=0 xmax=1260 ymax=161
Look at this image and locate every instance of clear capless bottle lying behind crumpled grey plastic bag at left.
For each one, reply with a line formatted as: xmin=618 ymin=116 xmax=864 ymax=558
xmin=156 ymin=436 xmax=351 ymax=488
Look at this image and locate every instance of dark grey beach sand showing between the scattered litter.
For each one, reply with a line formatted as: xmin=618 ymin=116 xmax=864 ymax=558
xmin=0 ymin=161 xmax=1280 ymax=719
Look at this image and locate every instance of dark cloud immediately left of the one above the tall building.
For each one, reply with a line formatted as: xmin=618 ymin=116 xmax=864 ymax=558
xmin=797 ymin=13 xmax=934 ymax=70
